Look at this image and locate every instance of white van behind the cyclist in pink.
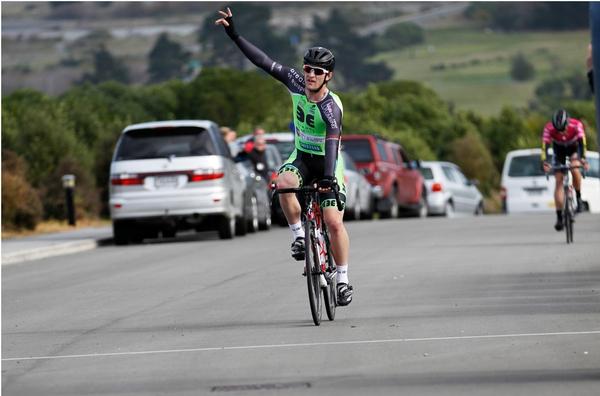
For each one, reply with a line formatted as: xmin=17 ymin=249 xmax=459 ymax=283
xmin=502 ymin=148 xmax=600 ymax=214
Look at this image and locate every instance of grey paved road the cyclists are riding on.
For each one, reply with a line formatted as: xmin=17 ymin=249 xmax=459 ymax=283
xmin=2 ymin=214 xmax=600 ymax=396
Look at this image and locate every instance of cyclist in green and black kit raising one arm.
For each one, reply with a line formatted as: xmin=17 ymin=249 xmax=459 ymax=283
xmin=215 ymin=8 xmax=353 ymax=305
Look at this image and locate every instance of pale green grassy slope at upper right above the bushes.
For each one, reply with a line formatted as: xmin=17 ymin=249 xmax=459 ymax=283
xmin=374 ymin=28 xmax=590 ymax=115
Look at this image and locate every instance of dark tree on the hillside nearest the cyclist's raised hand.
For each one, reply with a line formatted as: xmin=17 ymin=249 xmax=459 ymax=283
xmin=148 ymin=33 xmax=191 ymax=83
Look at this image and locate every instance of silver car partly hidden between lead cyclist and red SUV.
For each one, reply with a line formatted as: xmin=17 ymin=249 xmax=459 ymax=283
xmin=342 ymin=151 xmax=374 ymax=220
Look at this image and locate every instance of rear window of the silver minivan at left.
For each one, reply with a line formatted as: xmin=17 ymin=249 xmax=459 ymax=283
xmin=115 ymin=127 xmax=216 ymax=161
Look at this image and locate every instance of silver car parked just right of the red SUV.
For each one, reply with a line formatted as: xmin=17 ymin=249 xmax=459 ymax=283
xmin=420 ymin=161 xmax=483 ymax=217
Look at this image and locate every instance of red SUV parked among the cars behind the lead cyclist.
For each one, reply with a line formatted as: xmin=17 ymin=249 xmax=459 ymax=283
xmin=342 ymin=135 xmax=427 ymax=218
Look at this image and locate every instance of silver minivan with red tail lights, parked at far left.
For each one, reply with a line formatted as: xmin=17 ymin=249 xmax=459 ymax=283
xmin=109 ymin=120 xmax=245 ymax=244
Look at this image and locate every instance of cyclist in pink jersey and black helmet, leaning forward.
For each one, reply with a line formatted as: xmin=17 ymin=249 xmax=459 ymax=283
xmin=542 ymin=109 xmax=589 ymax=231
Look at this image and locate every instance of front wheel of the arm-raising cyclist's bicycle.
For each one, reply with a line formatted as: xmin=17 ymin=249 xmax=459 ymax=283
xmin=304 ymin=221 xmax=323 ymax=326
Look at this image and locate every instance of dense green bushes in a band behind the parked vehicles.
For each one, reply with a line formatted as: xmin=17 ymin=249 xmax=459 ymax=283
xmin=2 ymin=68 xmax=597 ymax=227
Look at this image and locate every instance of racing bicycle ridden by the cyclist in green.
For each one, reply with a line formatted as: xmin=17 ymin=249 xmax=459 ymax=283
xmin=276 ymin=184 xmax=342 ymax=326
